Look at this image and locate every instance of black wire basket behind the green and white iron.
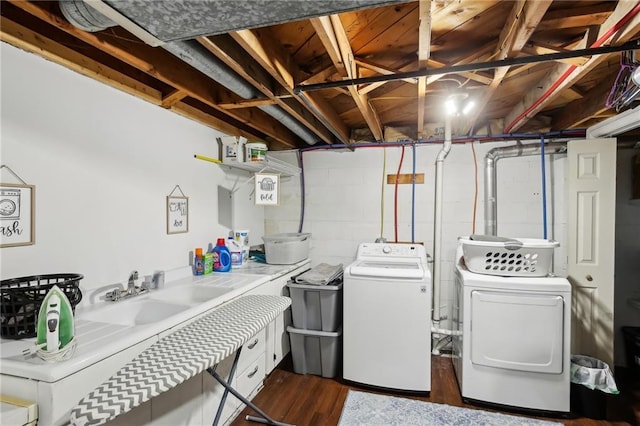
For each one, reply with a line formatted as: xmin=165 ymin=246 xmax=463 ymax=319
xmin=0 ymin=274 xmax=83 ymax=339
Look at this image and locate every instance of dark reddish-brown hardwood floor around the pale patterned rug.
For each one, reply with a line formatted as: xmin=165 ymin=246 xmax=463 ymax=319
xmin=232 ymin=356 xmax=640 ymax=426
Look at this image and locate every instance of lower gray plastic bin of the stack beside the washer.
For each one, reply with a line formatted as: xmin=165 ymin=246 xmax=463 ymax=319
xmin=287 ymin=326 xmax=342 ymax=377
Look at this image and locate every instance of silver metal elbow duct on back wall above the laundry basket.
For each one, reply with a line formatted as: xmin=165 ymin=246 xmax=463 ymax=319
xmin=484 ymin=142 xmax=567 ymax=235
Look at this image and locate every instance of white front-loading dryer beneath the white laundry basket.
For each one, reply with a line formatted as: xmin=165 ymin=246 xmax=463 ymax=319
xmin=453 ymin=250 xmax=571 ymax=413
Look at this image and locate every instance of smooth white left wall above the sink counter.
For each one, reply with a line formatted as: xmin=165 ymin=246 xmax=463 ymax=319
xmin=0 ymin=43 xmax=264 ymax=298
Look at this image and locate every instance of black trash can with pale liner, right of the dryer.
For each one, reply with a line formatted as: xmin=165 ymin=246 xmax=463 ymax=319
xmin=570 ymin=355 xmax=619 ymax=420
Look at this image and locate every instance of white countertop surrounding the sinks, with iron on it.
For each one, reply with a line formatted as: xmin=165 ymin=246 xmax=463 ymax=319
xmin=0 ymin=260 xmax=308 ymax=383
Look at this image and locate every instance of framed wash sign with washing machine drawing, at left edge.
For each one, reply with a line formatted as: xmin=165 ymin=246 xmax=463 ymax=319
xmin=0 ymin=183 xmax=36 ymax=247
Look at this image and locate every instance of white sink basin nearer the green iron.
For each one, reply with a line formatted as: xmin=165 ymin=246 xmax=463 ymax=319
xmin=77 ymin=298 xmax=190 ymax=326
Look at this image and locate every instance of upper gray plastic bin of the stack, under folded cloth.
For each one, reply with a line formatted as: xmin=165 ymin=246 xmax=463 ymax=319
xmin=287 ymin=282 xmax=342 ymax=331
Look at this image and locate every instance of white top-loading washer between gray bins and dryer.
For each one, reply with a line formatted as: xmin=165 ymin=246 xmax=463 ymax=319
xmin=342 ymin=243 xmax=432 ymax=392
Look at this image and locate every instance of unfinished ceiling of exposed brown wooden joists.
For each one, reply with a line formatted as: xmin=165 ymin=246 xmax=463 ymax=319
xmin=0 ymin=0 xmax=640 ymax=150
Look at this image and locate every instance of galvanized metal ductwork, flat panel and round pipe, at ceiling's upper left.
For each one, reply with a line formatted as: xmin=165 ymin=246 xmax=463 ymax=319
xmin=59 ymin=0 xmax=364 ymax=145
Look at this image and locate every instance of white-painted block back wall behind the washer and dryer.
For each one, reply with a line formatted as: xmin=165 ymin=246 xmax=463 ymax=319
xmin=265 ymin=141 xmax=566 ymax=326
